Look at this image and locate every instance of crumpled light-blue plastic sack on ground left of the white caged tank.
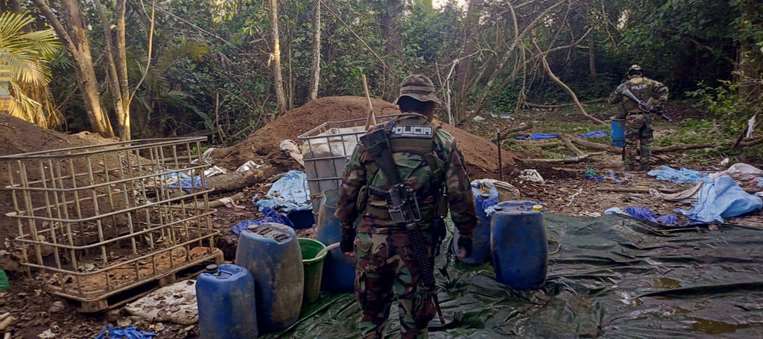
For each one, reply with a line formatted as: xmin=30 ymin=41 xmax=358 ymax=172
xmin=255 ymin=171 xmax=313 ymax=212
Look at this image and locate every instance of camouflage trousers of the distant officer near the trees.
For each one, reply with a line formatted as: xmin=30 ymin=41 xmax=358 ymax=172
xmin=623 ymin=114 xmax=654 ymax=171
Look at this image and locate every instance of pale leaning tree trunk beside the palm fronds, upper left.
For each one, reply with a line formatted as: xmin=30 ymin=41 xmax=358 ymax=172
xmin=34 ymin=0 xmax=114 ymax=137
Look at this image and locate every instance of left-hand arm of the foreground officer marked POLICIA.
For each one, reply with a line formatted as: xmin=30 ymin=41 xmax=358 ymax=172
xmin=335 ymin=145 xmax=366 ymax=253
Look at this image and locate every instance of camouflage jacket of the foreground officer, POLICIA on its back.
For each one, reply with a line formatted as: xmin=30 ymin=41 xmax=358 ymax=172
xmin=336 ymin=114 xmax=476 ymax=236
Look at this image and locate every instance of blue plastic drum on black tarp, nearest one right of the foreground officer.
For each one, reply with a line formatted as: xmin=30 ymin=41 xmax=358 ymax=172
xmin=490 ymin=201 xmax=548 ymax=290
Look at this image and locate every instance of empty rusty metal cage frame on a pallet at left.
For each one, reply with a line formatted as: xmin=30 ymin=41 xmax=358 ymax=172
xmin=0 ymin=137 xmax=220 ymax=302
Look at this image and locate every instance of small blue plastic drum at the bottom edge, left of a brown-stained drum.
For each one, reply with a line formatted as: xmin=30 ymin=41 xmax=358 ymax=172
xmin=196 ymin=264 xmax=257 ymax=339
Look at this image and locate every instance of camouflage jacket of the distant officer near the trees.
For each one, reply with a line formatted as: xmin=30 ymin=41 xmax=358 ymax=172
xmin=609 ymin=77 xmax=668 ymax=119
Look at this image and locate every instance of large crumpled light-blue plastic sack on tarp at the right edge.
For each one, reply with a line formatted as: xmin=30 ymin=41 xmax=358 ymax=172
xmin=681 ymin=175 xmax=763 ymax=223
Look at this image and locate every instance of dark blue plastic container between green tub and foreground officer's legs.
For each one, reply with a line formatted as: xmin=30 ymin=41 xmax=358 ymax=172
xmin=321 ymin=242 xmax=355 ymax=293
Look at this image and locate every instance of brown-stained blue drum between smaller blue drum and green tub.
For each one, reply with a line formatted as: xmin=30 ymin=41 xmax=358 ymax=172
xmin=236 ymin=223 xmax=305 ymax=333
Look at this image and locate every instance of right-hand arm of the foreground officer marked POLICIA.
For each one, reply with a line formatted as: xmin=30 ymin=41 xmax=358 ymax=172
xmin=445 ymin=143 xmax=477 ymax=255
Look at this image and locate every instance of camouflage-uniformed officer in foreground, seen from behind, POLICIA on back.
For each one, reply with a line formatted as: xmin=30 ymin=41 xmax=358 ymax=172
xmin=336 ymin=75 xmax=476 ymax=338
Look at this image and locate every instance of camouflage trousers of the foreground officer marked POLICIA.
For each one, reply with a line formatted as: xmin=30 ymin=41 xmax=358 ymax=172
xmin=355 ymin=231 xmax=435 ymax=338
